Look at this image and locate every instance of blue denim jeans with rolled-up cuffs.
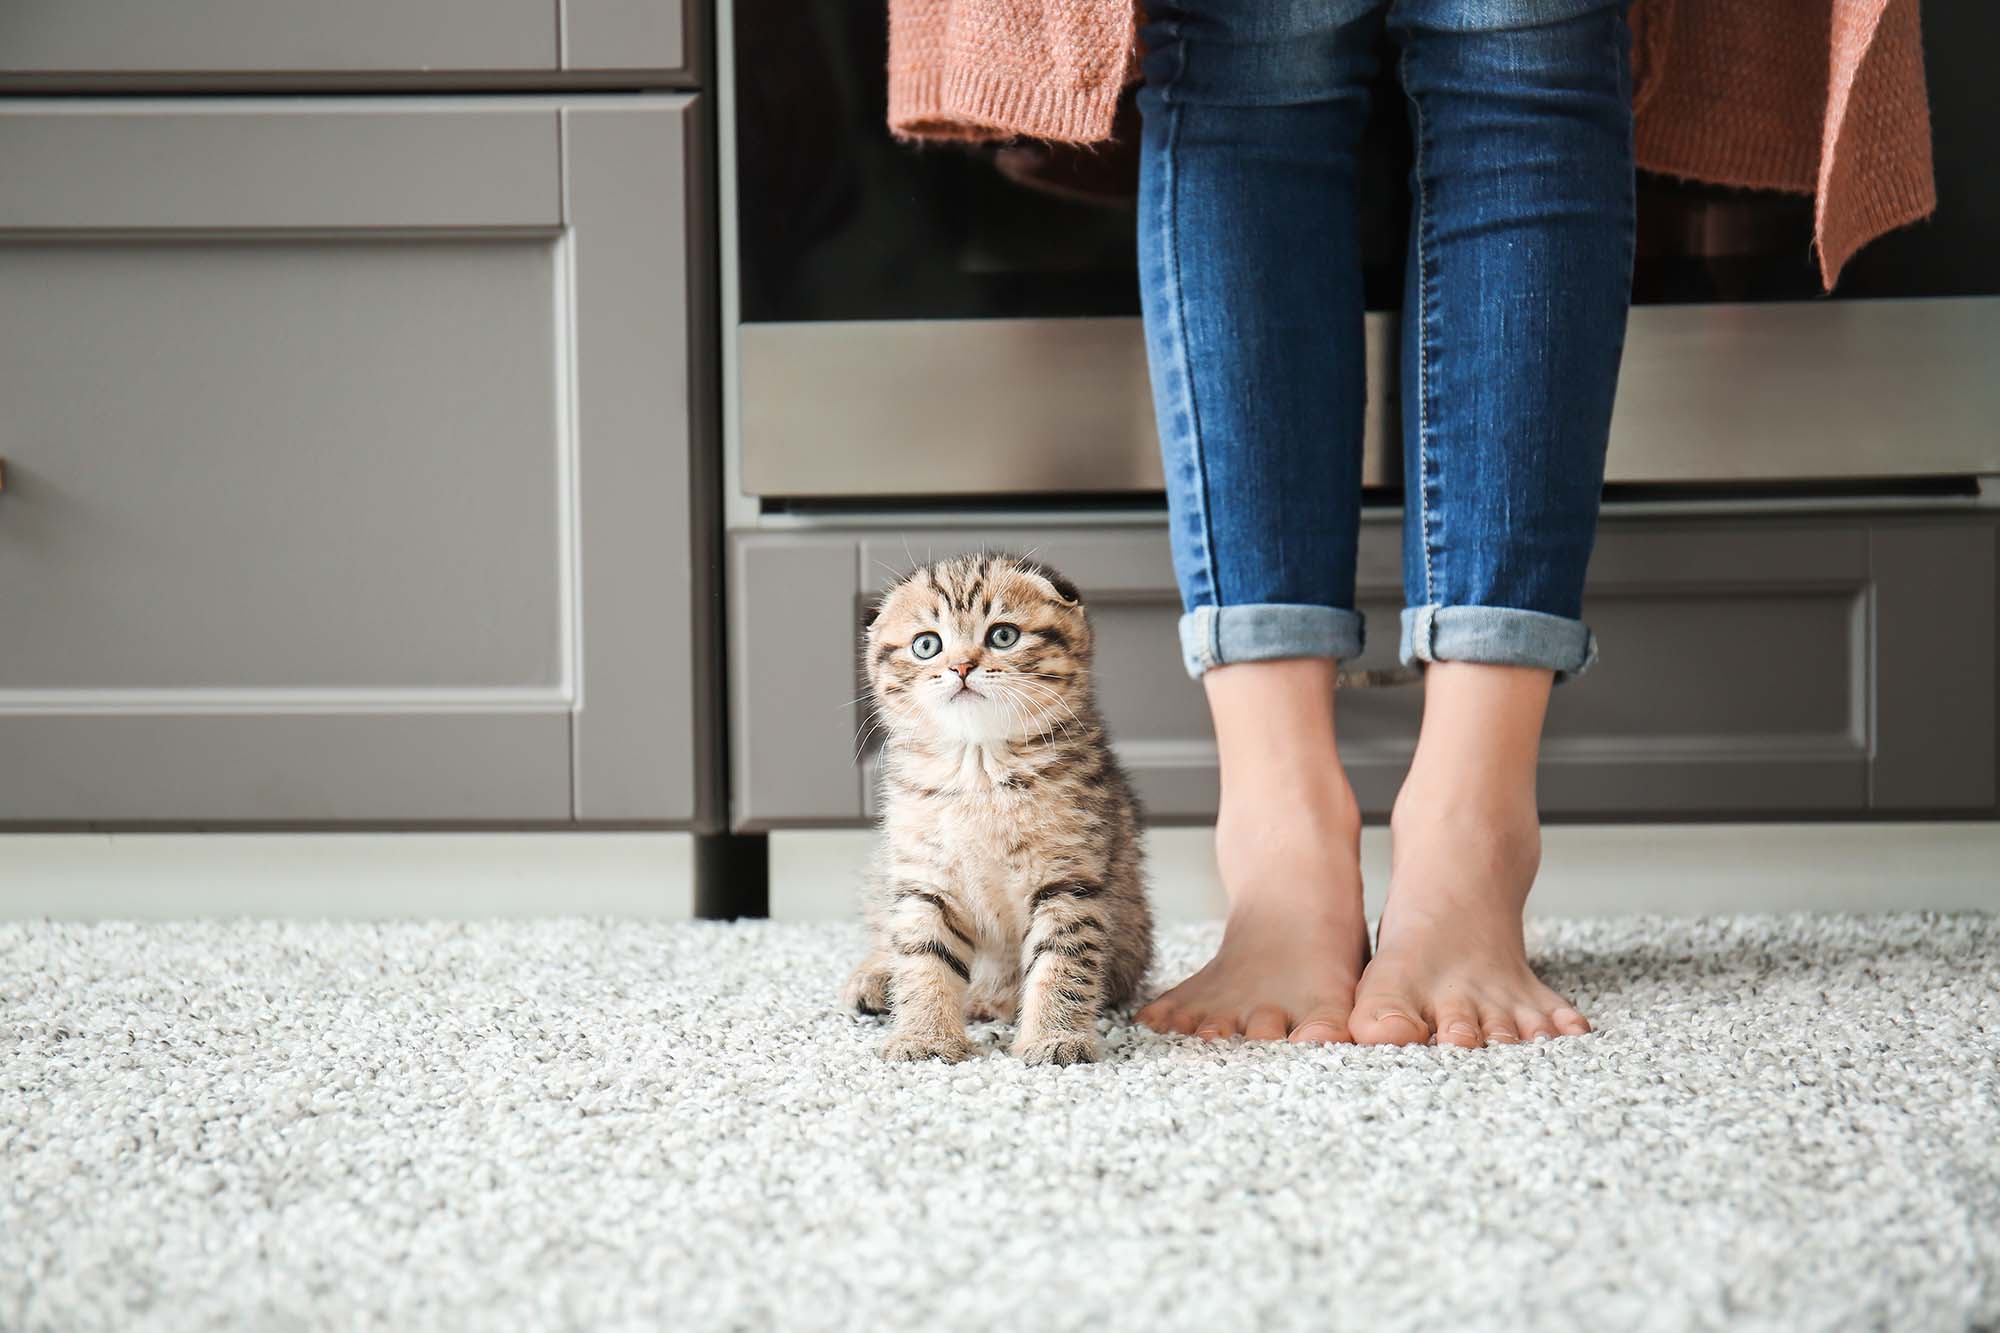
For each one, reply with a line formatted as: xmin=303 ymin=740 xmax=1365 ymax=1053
xmin=1140 ymin=0 xmax=1634 ymax=679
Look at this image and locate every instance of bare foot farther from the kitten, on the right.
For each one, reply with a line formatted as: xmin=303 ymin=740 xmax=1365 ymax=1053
xmin=1350 ymin=771 xmax=1590 ymax=1047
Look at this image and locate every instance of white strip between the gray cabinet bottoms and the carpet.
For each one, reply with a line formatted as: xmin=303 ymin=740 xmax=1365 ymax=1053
xmin=0 ymin=823 xmax=2000 ymax=923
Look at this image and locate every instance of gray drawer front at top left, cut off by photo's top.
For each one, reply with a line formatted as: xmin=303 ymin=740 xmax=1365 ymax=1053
xmin=0 ymin=0 xmax=706 ymax=92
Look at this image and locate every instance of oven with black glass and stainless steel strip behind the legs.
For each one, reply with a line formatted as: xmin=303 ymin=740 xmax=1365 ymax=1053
xmin=722 ymin=0 xmax=2000 ymax=510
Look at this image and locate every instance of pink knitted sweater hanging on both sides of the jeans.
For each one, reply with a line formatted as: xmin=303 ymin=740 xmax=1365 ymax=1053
xmin=888 ymin=0 xmax=1920 ymax=288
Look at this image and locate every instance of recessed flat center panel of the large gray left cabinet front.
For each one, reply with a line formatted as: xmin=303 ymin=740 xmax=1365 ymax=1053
xmin=0 ymin=240 xmax=566 ymax=697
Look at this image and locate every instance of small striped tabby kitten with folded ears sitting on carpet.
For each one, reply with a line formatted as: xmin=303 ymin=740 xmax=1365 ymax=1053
xmin=846 ymin=554 xmax=1152 ymax=1065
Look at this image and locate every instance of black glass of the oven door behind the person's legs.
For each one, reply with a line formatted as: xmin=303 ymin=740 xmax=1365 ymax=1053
xmin=732 ymin=0 xmax=2000 ymax=322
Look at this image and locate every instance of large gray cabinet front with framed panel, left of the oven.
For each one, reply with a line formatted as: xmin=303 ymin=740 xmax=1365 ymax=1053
xmin=0 ymin=96 xmax=700 ymax=827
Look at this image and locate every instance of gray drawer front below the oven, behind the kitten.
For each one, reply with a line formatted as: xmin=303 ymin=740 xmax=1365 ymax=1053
xmin=730 ymin=510 xmax=2000 ymax=831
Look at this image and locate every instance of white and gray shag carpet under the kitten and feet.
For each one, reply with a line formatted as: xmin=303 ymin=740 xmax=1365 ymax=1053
xmin=0 ymin=917 xmax=2000 ymax=1333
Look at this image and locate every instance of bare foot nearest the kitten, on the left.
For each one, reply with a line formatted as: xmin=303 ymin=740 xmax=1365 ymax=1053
xmin=1138 ymin=777 xmax=1368 ymax=1041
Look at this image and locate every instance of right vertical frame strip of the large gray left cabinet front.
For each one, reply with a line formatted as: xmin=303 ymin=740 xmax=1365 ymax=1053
xmin=564 ymin=108 xmax=696 ymax=821
